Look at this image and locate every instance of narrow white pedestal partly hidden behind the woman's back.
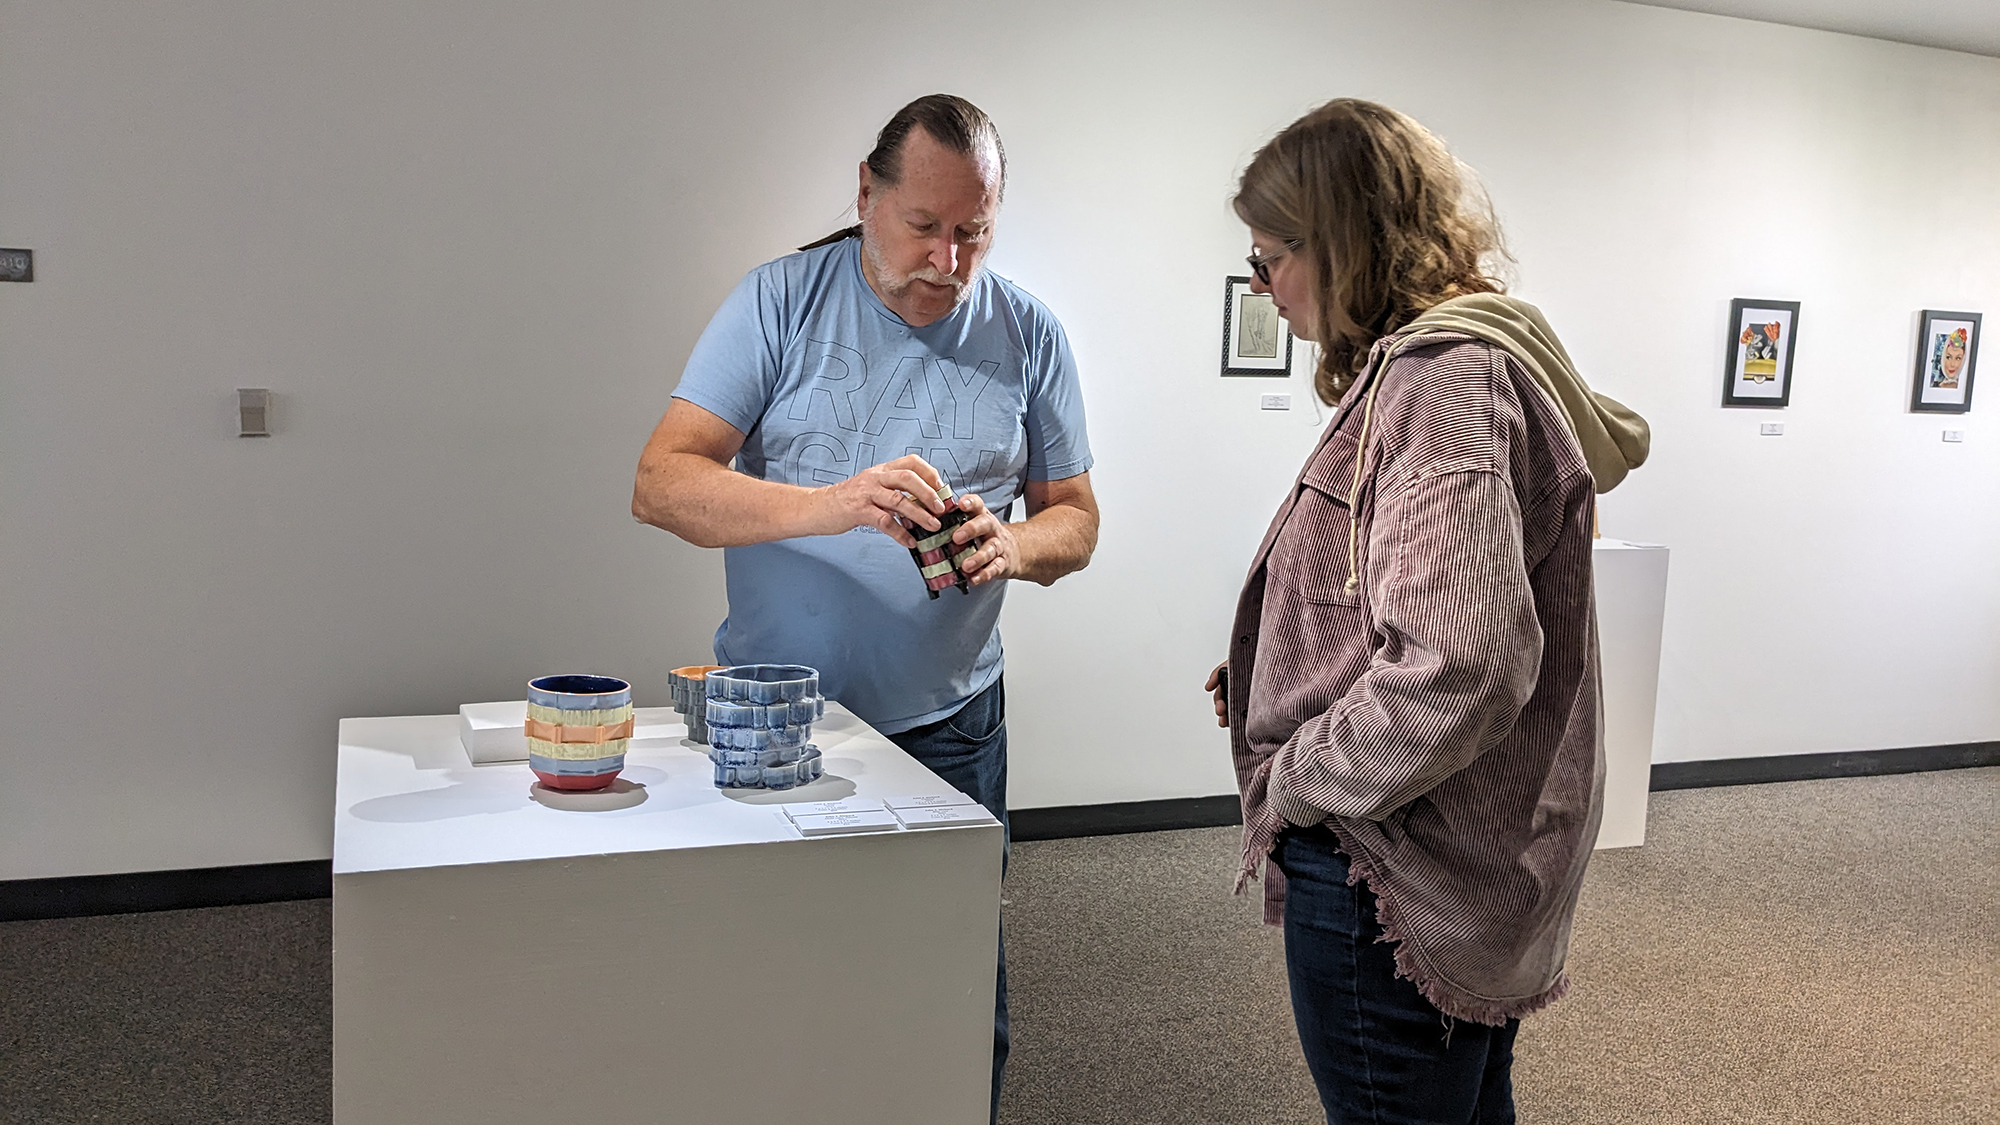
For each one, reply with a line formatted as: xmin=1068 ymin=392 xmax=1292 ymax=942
xmin=1594 ymin=538 xmax=1666 ymax=847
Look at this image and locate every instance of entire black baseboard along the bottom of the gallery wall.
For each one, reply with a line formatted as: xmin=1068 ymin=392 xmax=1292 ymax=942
xmin=0 ymin=743 xmax=2000 ymax=923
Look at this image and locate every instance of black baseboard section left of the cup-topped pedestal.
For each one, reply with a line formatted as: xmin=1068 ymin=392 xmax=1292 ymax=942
xmin=0 ymin=859 xmax=334 ymax=923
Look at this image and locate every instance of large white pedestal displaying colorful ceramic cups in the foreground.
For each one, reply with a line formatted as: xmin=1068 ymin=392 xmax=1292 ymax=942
xmin=334 ymin=705 xmax=1016 ymax=1125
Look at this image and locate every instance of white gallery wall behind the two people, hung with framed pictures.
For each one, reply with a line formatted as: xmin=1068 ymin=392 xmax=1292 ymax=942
xmin=0 ymin=0 xmax=2000 ymax=879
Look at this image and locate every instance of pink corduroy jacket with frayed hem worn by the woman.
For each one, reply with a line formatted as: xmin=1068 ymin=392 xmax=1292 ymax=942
xmin=1228 ymin=324 xmax=1604 ymax=1025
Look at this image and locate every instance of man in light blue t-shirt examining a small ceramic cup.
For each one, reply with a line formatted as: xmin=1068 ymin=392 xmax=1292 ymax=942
xmin=632 ymin=94 xmax=1098 ymax=1113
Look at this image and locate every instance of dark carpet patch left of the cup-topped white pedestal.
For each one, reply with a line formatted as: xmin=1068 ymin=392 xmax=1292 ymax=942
xmin=0 ymin=899 xmax=334 ymax=1125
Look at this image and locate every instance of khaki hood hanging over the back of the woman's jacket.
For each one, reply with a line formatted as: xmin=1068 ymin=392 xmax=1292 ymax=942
xmin=1392 ymin=292 xmax=1652 ymax=492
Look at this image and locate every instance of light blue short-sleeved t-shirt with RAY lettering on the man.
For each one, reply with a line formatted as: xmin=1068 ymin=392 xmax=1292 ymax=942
xmin=674 ymin=238 xmax=1090 ymax=735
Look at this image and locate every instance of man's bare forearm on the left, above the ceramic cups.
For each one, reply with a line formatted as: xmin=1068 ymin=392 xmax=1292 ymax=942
xmin=632 ymin=452 xmax=820 ymax=546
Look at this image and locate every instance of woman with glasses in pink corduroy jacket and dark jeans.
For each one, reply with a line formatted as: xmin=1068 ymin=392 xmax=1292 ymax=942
xmin=1208 ymin=98 xmax=1650 ymax=1125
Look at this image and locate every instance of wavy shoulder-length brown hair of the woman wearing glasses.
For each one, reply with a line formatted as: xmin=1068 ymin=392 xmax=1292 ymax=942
xmin=1232 ymin=98 xmax=1506 ymax=404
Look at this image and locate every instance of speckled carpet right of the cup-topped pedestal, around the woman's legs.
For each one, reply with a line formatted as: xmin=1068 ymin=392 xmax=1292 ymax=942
xmin=1002 ymin=769 xmax=2000 ymax=1125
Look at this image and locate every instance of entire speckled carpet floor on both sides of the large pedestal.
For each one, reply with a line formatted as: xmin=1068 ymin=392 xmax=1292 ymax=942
xmin=0 ymin=769 xmax=2000 ymax=1125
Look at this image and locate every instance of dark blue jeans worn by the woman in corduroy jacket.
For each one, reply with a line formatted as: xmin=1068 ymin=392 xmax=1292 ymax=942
xmin=1272 ymin=812 xmax=1520 ymax=1125
